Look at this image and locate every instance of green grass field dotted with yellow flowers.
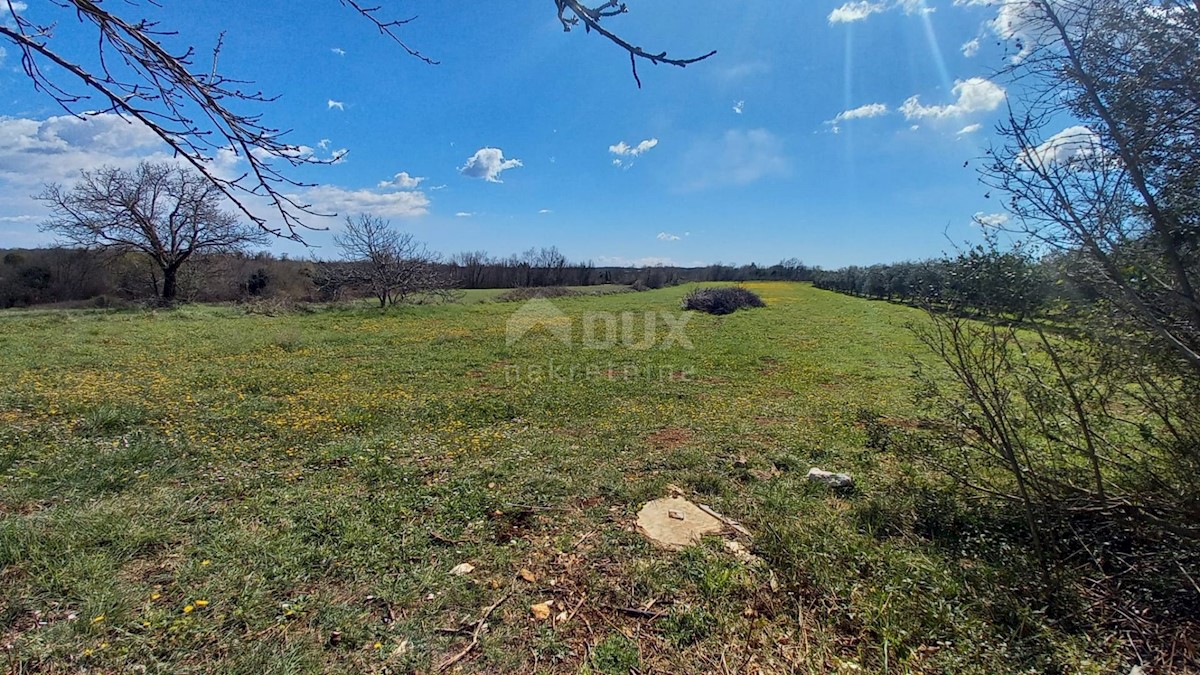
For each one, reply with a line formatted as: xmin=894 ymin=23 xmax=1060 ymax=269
xmin=0 ymin=283 xmax=1120 ymax=674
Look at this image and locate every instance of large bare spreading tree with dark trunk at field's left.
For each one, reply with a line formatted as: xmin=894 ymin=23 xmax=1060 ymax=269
xmin=37 ymin=162 xmax=266 ymax=303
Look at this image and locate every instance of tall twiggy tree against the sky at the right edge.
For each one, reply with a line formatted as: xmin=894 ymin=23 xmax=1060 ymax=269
xmin=984 ymin=0 xmax=1200 ymax=377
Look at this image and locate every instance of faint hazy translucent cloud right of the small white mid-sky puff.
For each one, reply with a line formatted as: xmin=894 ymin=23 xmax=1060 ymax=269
xmin=682 ymin=129 xmax=788 ymax=190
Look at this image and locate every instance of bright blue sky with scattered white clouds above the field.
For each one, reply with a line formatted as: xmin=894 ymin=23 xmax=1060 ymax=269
xmin=0 ymin=0 xmax=1032 ymax=267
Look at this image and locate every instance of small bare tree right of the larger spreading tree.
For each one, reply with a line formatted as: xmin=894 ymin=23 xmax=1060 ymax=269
xmin=316 ymin=215 xmax=454 ymax=307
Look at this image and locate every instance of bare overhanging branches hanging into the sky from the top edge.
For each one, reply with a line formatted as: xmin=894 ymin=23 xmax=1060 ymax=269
xmin=0 ymin=0 xmax=713 ymax=240
